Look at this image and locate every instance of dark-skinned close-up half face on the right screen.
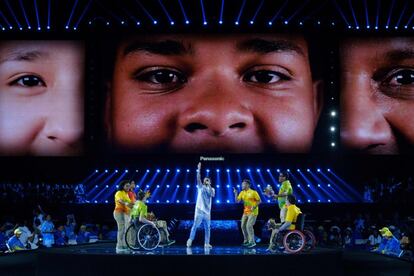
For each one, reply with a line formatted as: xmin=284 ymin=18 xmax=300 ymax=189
xmin=340 ymin=37 xmax=414 ymax=154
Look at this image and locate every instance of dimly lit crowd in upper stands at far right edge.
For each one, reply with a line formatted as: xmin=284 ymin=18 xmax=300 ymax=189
xmin=363 ymin=176 xmax=414 ymax=203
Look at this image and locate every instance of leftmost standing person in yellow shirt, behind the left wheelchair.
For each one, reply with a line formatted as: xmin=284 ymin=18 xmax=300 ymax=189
xmin=114 ymin=180 xmax=133 ymax=253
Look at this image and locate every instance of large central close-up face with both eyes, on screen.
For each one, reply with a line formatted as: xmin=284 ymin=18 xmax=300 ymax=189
xmin=105 ymin=34 xmax=323 ymax=153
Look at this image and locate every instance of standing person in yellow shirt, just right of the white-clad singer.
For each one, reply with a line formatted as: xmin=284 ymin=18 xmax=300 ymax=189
xmin=233 ymin=179 xmax=262 ymax=248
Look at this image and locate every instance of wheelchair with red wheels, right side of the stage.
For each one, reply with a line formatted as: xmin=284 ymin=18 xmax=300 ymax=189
xmin=272 ymin=214 xmax=316 ymax=254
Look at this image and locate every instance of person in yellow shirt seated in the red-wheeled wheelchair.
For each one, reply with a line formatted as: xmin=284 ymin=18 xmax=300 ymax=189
xmin=268 ymin=195 xmax=302 ymax=250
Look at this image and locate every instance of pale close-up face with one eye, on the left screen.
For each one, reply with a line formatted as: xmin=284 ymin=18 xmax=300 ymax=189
xmin=0 ymin=40 xmax=85 ymax=156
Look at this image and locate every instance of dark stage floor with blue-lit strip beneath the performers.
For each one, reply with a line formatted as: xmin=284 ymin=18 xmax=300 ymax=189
xmin=0 ymin=243 xmax=411 ymax=276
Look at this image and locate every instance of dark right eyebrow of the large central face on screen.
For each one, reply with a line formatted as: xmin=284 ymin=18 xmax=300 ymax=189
xmin=237 ymin=38 xmax=305 ymax=56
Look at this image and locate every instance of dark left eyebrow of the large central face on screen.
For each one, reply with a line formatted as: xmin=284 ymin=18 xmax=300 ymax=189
xmin=124 ymin=40 xmax=192 ymax=56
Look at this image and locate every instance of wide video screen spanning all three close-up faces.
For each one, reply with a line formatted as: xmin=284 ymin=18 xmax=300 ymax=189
xmin=0 ymin=35 xmax=414 ymax=156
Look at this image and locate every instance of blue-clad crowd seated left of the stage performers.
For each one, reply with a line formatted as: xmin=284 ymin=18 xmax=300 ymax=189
xmin=0 ymin=206 xmax=116 ymax=252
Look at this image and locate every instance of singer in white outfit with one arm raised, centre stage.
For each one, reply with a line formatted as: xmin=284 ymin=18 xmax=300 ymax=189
xmin=187 ymin=162 xmax=215 ymax=249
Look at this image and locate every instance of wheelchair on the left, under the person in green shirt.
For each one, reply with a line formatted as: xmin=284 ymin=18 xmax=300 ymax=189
xmin=125 ymin=220 xmax=165 ymax=251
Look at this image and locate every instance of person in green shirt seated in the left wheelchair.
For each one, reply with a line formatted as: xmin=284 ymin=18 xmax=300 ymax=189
xmin=131 ymin=190 xmax=175 ymax=246
